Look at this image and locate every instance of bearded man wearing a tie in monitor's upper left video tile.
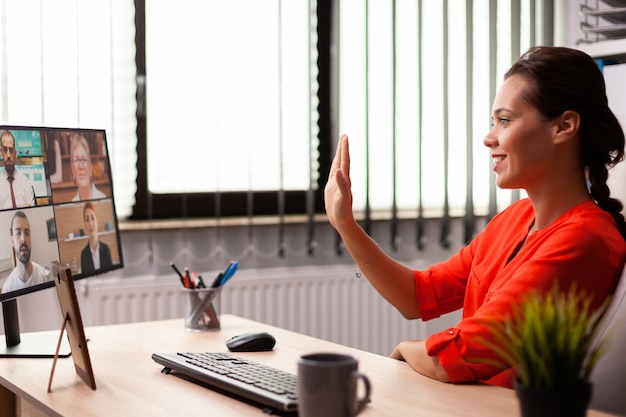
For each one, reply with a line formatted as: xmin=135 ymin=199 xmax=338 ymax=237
xmin=0 ymin=130 xmax=35 ymax=209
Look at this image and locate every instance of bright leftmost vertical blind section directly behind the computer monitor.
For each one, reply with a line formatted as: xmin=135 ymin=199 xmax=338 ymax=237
xmin=0 ymin=0 xmax=137 ymax=216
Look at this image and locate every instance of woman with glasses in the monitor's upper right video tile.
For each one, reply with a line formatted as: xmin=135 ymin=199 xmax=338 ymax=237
xmin=70 ymin=134 xmax=106 ymax=201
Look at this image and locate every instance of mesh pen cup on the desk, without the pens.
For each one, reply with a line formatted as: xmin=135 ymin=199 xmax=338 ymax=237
xmin=182 ymin=288 xmax=221 ymax=332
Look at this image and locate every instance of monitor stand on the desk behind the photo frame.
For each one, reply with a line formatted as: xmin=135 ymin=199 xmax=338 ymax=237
xmin=0 ymin=299 xmax=72 ymax=358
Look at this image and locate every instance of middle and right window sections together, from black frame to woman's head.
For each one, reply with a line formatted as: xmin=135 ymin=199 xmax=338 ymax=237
xmin=133 ymin=0 xmax=536 ymax=223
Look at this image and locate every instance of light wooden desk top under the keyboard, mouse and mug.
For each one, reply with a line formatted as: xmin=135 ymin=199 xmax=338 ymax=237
xmin=0 ymin=315 xmax=608 ymax=417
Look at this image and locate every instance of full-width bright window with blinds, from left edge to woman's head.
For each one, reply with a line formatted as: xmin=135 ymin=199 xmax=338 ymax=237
xmin=0 ymin=0 xmax=551 ymax=226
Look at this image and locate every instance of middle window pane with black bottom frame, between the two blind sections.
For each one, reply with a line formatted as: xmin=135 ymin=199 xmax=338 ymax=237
xmin=134 ymin=0 xmax=322 ymax=218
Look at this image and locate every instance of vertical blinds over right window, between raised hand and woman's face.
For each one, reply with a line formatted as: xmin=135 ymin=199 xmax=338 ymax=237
xmin=338 ymin=0 xmax=537 ymax=245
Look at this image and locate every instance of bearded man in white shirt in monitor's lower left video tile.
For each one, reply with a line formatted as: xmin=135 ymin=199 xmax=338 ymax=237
xmin=2 ymin=211 xmax=52 ymax=293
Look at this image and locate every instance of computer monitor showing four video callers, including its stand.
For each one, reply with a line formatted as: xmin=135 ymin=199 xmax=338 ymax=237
xmin=0 ymin=126 xmax=124 ymax=357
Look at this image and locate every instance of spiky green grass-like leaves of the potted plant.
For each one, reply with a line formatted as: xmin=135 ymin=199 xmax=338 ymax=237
xmin=482 ymin=285 xmax=609 ymax=389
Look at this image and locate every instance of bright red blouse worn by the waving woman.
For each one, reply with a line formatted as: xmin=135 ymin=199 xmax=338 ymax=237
xmin=414 ymin=199 xmax=626 ymax=387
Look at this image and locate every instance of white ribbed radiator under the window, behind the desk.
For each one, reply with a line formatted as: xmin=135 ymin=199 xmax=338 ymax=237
xmin=77 ymin=265 xmax=458 ymax=355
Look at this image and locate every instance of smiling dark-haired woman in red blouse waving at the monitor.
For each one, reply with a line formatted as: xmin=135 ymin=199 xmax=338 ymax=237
xmin=325 ymin=47 xmax=626 ymax=387
